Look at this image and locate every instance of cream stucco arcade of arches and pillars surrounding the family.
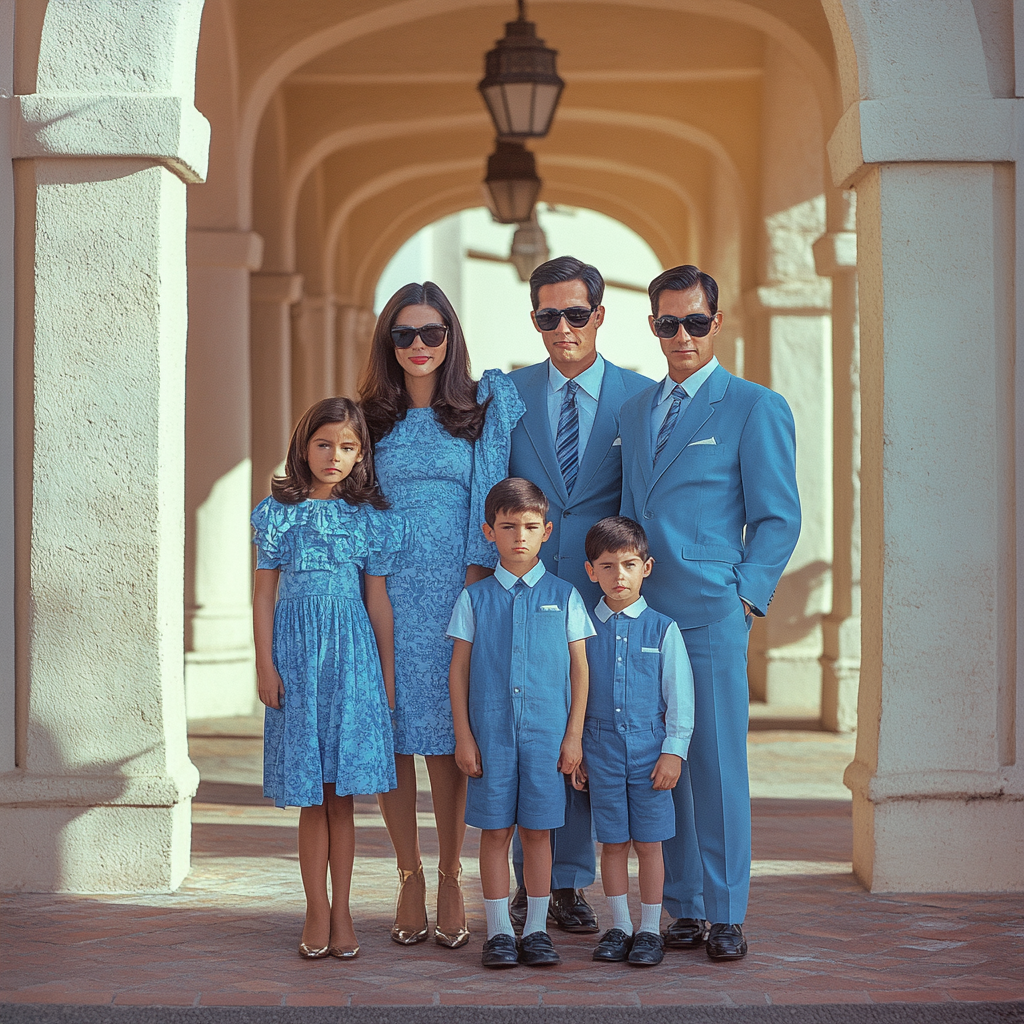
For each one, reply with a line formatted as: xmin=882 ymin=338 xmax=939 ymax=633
xmin=0 ymin=0 xmax=1024 ymax=891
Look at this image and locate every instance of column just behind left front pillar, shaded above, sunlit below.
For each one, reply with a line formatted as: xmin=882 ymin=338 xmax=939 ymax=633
xmin=185 ymin=229 xmax=262 ymax=718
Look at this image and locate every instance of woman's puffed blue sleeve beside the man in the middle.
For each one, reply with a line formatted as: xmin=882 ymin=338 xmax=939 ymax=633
xmin=465 ymin=370 xmax=526 ymax=568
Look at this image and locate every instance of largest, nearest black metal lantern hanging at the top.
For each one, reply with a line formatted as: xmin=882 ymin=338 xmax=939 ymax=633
xmin=477 ymin=0 xmax=565 ymax=138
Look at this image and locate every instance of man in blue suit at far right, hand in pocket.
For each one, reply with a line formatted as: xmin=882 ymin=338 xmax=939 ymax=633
xmin=620 ymin=266 xmax=800 ymax=959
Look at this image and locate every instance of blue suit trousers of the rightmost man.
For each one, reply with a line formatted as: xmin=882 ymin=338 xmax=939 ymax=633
xmin=662 ymin=600 xmax=753 ymax=925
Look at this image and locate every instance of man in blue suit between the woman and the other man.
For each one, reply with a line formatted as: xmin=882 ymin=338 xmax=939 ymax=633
xmin=509 ymin=256 xmax=653 ymax=932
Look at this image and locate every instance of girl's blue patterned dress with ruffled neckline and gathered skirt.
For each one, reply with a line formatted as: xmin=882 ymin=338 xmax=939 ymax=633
xmin=252 ymin=498 xmax=408 ymax=807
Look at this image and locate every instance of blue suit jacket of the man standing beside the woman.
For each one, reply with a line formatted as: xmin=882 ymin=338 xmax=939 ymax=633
xmin=509 ymin=359 xmax=652 ymax=609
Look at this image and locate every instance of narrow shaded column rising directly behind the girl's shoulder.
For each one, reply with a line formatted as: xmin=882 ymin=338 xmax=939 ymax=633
xmin=250 ymin=273 xmax=303 ymax=505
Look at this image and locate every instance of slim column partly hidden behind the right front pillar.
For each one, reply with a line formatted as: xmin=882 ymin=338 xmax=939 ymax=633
xmin=814 ymin=203 xmax=860 ymax=732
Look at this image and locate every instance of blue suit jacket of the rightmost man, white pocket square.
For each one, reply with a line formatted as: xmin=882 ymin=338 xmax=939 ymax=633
xmin=620 ymin=367 xmax=800 ymax=629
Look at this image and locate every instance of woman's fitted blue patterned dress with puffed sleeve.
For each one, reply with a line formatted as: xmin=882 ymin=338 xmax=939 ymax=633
xmin=375 ymin=370 xmax=525 ymax=754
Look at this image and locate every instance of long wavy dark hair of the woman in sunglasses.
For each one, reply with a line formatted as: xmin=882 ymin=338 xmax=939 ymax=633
xmin=359 ymin=281 xmax=490 ymax=441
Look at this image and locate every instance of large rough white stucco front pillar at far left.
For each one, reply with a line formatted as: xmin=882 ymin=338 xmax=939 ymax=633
xmin=0 ymin=83 xmax=209 ymax=892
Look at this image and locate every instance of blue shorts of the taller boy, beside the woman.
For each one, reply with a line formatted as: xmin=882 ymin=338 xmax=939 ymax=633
xmin=466 ymin=735 xmax=569 ymax=829
